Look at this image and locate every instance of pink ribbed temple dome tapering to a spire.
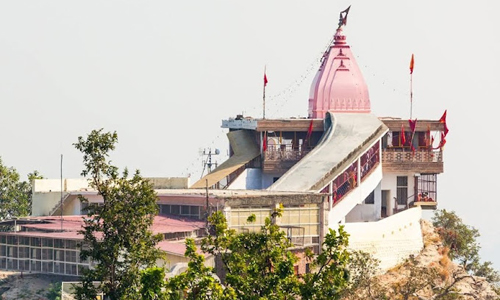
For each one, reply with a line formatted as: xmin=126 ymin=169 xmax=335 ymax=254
xmin=308 ymin=26 xmax=371 ymax=119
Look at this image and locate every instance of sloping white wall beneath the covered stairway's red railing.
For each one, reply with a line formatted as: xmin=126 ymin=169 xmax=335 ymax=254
xmin=328 ymin=164 xmax=382 ymax=227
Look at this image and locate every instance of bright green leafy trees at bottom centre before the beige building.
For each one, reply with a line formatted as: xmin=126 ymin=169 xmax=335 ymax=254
xmin=169 ymin=209 xmax=349 ymax=300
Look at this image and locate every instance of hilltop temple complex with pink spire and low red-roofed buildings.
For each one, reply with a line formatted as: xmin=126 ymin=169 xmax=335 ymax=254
xmin=0 ymin=9 xmax=448 ymax=276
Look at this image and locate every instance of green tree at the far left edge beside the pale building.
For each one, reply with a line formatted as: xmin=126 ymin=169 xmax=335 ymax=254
xmin=0 ymin=158 xmax=43 ymax=220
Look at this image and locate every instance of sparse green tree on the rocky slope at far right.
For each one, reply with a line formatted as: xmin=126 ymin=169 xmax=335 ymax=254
xmin=432 ymin=209 xmax=500 ymax=285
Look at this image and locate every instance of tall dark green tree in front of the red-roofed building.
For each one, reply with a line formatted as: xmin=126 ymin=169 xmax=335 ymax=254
xmin=74 ymin=129 xmax=161 ymax=300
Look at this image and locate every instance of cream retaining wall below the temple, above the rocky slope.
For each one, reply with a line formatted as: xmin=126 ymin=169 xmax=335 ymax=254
xmin=345 ymin=207 xmax=424 ymax=271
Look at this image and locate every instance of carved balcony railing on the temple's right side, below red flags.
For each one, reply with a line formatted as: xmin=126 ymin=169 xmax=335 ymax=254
xmin=382 ymin=148 xmax=444 ymax=174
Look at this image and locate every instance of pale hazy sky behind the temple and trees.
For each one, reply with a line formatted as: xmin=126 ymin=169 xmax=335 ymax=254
xmin=0 ymin=0 xmax=500 ymax=269
